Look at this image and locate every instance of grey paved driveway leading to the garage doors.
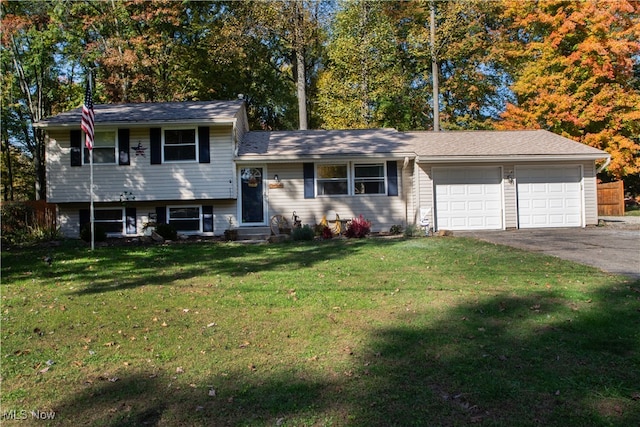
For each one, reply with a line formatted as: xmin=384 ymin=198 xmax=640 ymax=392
xmin=455 ymin=217 xmax=640 ymax=279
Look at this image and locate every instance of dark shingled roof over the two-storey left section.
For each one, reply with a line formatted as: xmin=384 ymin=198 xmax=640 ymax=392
xmin=34 ymin=100 xmax=244 ymax=127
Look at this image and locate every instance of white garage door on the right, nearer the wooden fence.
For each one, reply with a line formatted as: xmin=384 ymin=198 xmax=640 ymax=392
xmin=516 ymin=166 xmax=582 ymax=228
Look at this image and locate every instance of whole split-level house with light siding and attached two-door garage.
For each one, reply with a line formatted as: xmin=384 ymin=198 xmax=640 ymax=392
xmin=35 ymin=100 xmax=609 ymax=241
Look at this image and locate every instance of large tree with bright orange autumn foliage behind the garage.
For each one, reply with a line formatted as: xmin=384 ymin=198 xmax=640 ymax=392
xmin=499 ymin=0 xmax=640 ymax=179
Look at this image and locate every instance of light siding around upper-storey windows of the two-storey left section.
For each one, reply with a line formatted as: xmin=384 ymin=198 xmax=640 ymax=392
xmin=47 ymin=126 xmax=236 ymax=203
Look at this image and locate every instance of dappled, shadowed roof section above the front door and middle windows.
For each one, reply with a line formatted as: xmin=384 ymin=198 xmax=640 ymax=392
xmin=238 ymin=129 xmax=412 ymax=160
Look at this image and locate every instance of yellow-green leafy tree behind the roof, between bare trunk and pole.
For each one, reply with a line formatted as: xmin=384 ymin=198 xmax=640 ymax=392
xmin=318 ymin=0 xmax=404 ymax=128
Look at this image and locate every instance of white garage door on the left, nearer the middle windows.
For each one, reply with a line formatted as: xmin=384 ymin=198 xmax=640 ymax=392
xmin=433 ymin=167 xmax=502 ymax=230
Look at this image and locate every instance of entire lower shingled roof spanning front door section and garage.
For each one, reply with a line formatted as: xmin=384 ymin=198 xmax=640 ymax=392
xmin=238 ymin=129 xmax=608 ymax=162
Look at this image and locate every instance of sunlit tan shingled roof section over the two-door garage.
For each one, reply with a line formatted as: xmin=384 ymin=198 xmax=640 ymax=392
xmin=407 ymin=130 xmax=609 ymax=161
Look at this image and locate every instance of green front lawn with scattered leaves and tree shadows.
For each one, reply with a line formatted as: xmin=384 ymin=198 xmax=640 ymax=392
xmin=0 ymin=238 xmax=640 ymax=426
